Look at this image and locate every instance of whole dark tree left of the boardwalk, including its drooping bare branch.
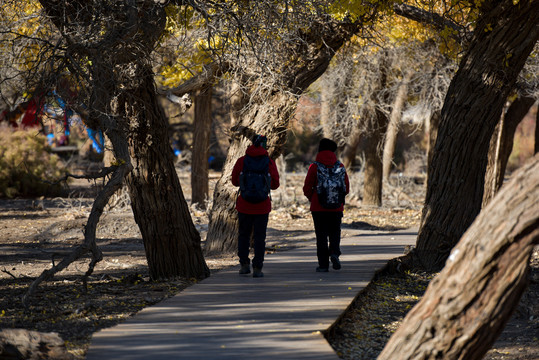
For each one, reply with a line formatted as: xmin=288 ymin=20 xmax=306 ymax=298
xmin=2 ymin=0 xmax=213 ymax=292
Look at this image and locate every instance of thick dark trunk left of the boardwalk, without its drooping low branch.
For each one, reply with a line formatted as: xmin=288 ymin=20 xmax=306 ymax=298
xmin=40 ymin=0 xmax=209 ymax=279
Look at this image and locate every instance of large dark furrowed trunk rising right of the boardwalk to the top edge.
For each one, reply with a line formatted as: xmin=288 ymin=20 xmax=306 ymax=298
xmin=416 ymin=0 xmax=539 ymax=270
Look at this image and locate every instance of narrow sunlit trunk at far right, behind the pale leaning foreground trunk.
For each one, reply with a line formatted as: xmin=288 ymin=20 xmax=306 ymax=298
xmin=482 ymin=97 xmax=535 ymax=207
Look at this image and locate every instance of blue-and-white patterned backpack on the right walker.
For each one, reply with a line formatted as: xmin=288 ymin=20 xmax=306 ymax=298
xmin=315 ymin=161 xmax=346 ymax=209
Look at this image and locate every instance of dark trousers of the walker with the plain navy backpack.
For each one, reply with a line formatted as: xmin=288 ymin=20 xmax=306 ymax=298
xmin=238 ymin=212 xmax=269 ymax=269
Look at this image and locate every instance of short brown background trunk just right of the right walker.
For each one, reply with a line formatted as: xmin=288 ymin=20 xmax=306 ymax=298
xmin=363 ymin=110 xmax=388 ymax=206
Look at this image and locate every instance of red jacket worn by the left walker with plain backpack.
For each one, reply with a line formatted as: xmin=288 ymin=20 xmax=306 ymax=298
xmin=232 ymin=145 xmax=279 ymax=214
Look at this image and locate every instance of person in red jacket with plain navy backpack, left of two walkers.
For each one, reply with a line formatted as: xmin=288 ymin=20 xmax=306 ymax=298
xmin=232 ymin=135 xmax=279 ymax=277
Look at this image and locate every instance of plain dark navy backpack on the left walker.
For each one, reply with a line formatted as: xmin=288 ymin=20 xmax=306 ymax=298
xmin=239 ymin=155 xmax=271 ymax=204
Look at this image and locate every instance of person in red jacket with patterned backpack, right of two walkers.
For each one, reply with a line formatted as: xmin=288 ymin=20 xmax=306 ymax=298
xmin=303 ymin=139 xmax=350 ymax=272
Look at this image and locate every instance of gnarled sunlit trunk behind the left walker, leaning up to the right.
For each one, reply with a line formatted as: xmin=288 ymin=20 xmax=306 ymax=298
xmin=206 ymin=16 xmax=368 ymax=253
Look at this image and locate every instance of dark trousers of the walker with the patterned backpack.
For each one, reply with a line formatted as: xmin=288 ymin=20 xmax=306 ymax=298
xmin=312 ymin=211 xmax=342 ymax=268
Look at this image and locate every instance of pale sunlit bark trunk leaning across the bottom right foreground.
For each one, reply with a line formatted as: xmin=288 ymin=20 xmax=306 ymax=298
xmin=378 ymin=155 xmax=539 ymax=360
